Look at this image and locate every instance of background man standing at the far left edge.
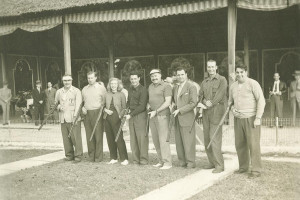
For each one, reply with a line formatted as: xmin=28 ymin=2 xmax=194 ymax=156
xmin=0 ymin=81 xmax=11 ymax=126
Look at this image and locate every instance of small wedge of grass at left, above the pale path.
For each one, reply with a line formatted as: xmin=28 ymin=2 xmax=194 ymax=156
xmin=0 ymin=149 xmax=58 ymax=164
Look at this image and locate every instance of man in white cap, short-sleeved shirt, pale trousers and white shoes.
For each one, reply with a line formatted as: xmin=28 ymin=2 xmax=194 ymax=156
xmin=148 ymin=69 xmax=172 ymax=169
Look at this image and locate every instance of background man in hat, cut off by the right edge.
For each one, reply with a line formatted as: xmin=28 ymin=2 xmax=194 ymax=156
xmin=290 ymin=70 xmax=300 ymax=125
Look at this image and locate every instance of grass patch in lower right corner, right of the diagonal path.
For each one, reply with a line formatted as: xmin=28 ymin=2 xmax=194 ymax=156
xmin=190 ymin=161 xmax=300 ymax=200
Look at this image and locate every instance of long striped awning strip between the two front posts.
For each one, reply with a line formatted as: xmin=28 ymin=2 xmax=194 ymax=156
xmin=65 ymin=0 xmax=228 ymax=23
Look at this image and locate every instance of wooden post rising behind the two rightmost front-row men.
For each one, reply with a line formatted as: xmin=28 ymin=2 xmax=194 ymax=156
xmin=227 ymin=0 xmax=237 ymax=124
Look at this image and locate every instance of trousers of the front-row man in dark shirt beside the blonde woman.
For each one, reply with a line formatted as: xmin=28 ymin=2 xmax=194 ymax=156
xmin=129 ymin=112 xmax=149 ymax=165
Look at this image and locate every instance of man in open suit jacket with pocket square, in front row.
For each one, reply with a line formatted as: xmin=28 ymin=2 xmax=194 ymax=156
xmin=172 ymin=66 xmax=197 ymax=168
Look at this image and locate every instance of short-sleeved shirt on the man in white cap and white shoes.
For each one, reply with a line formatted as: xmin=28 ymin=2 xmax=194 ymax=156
xmin=148 ymin=81 xmax=172 ymax=115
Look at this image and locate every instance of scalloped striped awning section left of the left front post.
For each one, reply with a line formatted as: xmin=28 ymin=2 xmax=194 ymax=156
xmin=0 ymin=16 xmax=62 ymax=36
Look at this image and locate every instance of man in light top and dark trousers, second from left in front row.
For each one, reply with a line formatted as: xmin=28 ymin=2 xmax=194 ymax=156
xmin=82 ymin=71 xmax=106 ymax=162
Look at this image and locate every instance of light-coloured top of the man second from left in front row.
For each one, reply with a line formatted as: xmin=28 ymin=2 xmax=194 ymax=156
xmin=82 ymin=82 xmax=106 ymax=110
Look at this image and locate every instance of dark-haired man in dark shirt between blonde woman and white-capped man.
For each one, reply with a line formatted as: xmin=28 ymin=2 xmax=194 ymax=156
xmin=126 ymin=60 xmax=149 ymax=165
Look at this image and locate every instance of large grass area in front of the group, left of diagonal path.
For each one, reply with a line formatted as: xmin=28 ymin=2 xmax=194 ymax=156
xmin=0 ymin=153 xmax=208 ymax=200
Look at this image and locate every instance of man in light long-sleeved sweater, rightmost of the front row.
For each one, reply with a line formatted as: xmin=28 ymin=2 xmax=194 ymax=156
xmin=228 ymin=64 xmax=266 ymax=178
